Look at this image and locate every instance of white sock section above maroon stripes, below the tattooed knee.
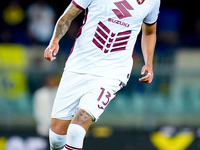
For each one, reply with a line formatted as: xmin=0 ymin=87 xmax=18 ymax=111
xmin=67 ymin=124 xmax=86 ymax=148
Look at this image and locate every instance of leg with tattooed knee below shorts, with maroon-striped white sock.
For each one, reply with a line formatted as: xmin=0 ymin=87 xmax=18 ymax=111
xmin=65 ymin=109 xmax=93 ymax=150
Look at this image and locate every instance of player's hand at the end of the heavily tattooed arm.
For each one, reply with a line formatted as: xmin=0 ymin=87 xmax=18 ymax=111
xmin=44 ymin=40 xmax=59 ymax=61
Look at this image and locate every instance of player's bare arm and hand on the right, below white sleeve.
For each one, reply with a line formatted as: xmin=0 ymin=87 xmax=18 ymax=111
xmin=139 ymin=23 xmax=157 ymax=83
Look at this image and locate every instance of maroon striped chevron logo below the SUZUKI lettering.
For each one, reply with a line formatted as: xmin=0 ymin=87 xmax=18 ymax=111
xmin=92 ymin=21 xmax=131 ymax=53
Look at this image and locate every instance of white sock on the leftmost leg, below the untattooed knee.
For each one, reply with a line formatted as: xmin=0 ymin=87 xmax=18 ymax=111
xmin=49 ymin=129 xmax=66 ymax=150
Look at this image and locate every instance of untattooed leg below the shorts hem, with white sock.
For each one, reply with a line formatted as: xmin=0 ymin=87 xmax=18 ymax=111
xmin=49 ymin=118 xmax=71 ymax=150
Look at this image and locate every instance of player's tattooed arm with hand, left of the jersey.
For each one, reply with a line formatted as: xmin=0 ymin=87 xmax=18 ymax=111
xmin=44 ymin=3 xmax=82 ymax=61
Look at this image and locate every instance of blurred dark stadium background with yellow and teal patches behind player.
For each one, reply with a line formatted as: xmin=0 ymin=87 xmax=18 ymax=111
xmin=0 ymin=0 xmax=200 ymax=150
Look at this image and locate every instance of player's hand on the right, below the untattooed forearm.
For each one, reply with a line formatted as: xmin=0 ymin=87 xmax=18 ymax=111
xmin=139 ymin=65 xmax=154 ymax=84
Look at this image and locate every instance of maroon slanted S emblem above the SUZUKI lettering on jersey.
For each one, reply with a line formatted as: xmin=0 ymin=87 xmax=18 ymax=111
xmin=112 ymin=0 xmax=134 ymax=19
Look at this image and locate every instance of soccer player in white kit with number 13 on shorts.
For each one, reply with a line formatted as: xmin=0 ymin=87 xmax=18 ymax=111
xmin=44 ymin=0 xmax=160 ymax=150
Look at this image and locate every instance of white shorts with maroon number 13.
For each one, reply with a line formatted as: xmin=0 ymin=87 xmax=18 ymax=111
xmin=51 ymin=71 xmax=122 ymax=121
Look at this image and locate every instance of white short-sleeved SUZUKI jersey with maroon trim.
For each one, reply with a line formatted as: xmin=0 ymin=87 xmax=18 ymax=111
xmin=65 ymin=0 xmax=160 ymax=84
